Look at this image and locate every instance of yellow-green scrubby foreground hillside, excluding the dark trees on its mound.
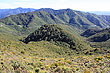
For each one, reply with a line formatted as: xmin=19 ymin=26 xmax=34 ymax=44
xmin=0 ymin=25 xmax=110 ymax=73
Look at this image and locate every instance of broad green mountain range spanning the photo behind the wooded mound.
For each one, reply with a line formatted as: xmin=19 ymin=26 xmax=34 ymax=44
xmin=0 ymin=8 xmax=110 ymax=34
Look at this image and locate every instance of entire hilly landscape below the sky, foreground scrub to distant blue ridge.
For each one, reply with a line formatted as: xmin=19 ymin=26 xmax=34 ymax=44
xmin=0 ymin=8 xmax=110 ymax=73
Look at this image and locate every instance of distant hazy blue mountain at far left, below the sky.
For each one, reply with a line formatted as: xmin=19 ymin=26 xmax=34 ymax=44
xmin=0 ymin=7 xmax=36 ymax=18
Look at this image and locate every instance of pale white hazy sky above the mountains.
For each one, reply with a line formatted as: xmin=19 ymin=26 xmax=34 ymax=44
xmin=0 ymin=0 xmax=110 ymax=11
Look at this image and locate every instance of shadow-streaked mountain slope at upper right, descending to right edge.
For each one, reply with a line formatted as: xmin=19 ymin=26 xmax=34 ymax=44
xmin=37 ymin=8 xmax=109 ymax=27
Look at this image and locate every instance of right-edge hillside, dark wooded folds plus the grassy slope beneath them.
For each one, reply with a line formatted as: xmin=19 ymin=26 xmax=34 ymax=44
xmin=81 ymin=28 xmax=110 ymax=48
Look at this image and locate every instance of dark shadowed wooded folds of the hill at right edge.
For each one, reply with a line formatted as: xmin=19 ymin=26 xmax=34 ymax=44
xmin=81 ymin=28 xmax=110 ymax=42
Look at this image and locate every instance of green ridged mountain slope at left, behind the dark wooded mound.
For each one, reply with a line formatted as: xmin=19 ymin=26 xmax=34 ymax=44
xmin=0 ymin=11 xmax=64 ymax=33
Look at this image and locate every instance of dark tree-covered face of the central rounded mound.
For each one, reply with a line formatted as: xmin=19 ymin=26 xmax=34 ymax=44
xmin=23 ymin=25 xmax=90 ymax=50
